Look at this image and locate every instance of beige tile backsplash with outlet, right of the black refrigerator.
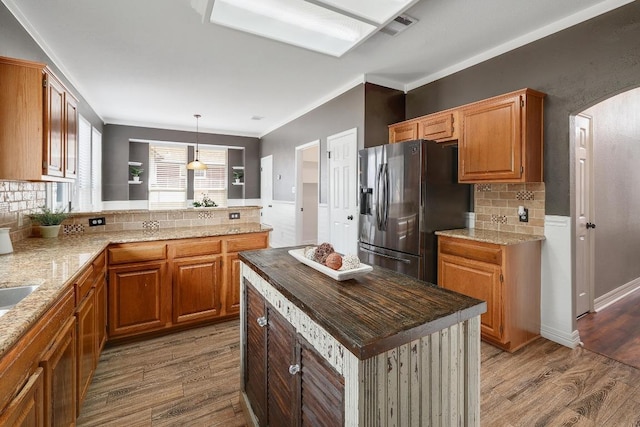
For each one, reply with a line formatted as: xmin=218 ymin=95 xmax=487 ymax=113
xmin=474 ymin=182 xmax=545 ymax=236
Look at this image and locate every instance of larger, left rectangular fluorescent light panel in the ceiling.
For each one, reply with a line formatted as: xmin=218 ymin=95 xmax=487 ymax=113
xmin=210 ymin=0 xmax=377 ymax=57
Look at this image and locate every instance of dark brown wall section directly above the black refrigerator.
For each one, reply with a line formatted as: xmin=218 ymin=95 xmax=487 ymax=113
xmin=364 ymin=83 xmax=405 ymax=148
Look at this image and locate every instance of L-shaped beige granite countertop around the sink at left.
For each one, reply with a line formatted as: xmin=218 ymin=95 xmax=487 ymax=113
xmin=0 ymin=223 xmax=271 ymax=357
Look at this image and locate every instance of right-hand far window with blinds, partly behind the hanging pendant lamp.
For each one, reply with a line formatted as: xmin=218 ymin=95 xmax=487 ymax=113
xmin=193 ymin=146 xmax=227 ymax=206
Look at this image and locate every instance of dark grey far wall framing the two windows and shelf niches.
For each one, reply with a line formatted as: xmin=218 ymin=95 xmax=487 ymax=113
xmin=102 ymin=124 xmax=260 ymax=201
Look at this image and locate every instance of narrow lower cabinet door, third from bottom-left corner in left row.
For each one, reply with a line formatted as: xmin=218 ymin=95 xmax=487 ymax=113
xmin=76 ymin=289 xmax=97 ymax=415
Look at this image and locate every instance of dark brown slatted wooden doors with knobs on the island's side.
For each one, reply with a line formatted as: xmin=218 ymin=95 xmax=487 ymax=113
xmin=243 ymin=284 xmax=344 ymax=427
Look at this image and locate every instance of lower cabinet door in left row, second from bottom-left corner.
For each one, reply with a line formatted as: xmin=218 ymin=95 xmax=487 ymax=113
xmin=40 ymin=317 xmax=76 ymax=426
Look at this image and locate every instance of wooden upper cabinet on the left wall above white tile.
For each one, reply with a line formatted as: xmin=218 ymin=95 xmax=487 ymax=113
xmin=0 ymin=57 xmax=78 ymax=181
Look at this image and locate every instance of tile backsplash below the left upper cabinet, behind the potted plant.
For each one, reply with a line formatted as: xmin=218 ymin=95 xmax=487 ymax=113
xmin=0 ymin=181 xmax=46 ymax=242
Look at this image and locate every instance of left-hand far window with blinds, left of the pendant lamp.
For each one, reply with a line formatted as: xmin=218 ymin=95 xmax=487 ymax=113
xmin=149 ymin=144 xmax=187 ymax=209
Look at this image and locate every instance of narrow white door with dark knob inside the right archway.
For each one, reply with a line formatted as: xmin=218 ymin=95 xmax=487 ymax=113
xmin=575 ymin=115 xmax=594 ymax=316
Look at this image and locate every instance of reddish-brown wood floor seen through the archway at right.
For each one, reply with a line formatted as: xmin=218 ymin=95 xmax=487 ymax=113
xmin=578 ymin=290 xmax=640 ymax=368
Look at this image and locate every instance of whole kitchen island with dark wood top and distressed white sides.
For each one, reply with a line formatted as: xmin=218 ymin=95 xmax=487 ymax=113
xmin=240 ymin=248 xmax=486 ymax=426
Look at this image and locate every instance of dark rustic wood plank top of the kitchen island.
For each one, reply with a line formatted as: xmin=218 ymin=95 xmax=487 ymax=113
xmin=240 ymin=248 xmax=487 ymax=360
